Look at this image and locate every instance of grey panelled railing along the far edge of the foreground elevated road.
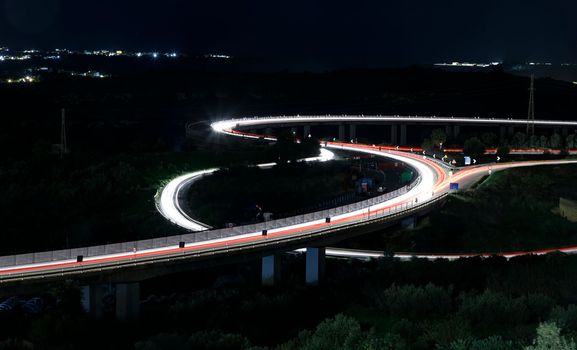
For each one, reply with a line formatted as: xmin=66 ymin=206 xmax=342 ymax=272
xmin=0 ymin=176 xmax=421 ymax=267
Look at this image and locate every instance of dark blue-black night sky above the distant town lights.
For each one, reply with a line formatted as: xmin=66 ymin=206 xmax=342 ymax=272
xmin=0 ymin=0 xmax=577 ymax=67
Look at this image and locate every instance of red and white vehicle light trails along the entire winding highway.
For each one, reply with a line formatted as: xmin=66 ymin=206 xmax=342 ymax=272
xmin=0 ymin=116 xmax=577 ymax=282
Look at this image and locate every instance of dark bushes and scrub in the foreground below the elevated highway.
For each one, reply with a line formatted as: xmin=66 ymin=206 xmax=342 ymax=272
xmin=5 ymin=254 xmax=577 ymax=350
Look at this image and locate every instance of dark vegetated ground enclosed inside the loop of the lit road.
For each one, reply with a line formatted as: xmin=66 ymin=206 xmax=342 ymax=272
xmin=189 ymin=154 xmax=410 ymax=227
